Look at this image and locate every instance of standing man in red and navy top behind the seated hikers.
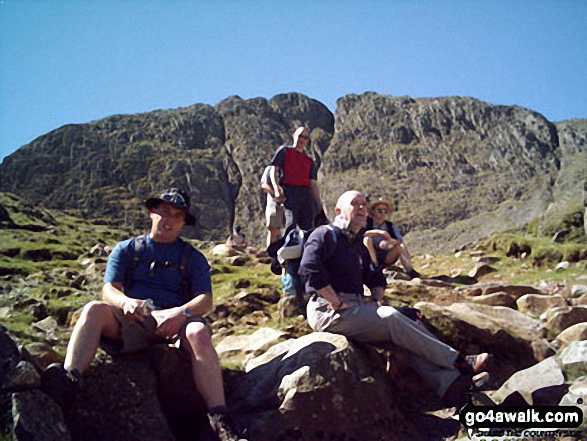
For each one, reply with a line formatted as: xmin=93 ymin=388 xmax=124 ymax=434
xmin=271 ymin=127 xmax=323 ymax=232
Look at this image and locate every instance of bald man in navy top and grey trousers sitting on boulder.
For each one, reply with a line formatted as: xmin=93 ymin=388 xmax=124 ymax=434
xmin=299 ymin=191 xmax=489 ymax=406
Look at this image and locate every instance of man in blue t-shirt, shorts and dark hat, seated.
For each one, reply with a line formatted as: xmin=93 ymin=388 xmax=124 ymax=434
xmin=41 ymin=188 xmax=238 ymax=440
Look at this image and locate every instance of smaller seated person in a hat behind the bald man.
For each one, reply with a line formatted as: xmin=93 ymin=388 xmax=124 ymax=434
xmin=364 ymin=198 xmax=420 ymax=279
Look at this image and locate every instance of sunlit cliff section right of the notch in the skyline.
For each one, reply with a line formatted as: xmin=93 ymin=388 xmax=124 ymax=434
xmin=324 ymin=93 xmax=560 ymax=229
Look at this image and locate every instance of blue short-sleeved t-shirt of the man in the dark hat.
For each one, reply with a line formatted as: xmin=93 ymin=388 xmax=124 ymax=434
xmin=104 ymin=235 xmax=212 ymax=308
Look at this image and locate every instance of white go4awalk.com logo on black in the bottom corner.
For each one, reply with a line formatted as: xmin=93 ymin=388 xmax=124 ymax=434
xmin=455 ymin=402 xmax=583 ymax=439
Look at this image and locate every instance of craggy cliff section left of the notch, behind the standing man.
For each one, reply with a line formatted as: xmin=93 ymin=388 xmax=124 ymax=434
xmin=0 ymin=93 xmax=334 ymax=242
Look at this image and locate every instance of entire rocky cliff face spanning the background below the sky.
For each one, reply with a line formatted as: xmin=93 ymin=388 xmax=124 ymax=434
xmin=0 ymin=92 xmax=587 ymax=250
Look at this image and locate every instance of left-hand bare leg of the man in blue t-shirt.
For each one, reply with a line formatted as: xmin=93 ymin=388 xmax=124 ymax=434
xmin=64 ymin=302 xmax=120 ymax=373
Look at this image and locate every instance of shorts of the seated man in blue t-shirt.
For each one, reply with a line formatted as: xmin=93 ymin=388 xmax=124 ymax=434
xmin=100 ymin=306 xmax=212 ymax=355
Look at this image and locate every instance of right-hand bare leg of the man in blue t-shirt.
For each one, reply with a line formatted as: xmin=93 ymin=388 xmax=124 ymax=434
xmin=182 ymin=322 xmax=226 ymax=409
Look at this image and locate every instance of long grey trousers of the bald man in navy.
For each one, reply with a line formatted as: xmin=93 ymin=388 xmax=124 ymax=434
xmin=307 ymin=293 xmax=460 ymax=396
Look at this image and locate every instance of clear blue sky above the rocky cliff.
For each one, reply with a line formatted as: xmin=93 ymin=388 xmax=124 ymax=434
xmin=0 ymin=0 xmax=587 ymax=160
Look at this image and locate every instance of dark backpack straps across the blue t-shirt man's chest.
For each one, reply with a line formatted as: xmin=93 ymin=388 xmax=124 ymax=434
xmin=124 ymin=234 xmax=193 ymax=302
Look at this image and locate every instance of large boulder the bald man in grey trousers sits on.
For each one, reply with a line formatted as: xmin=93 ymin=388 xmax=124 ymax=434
xmin=230 ymin=333 xmax=426 ymax=441
